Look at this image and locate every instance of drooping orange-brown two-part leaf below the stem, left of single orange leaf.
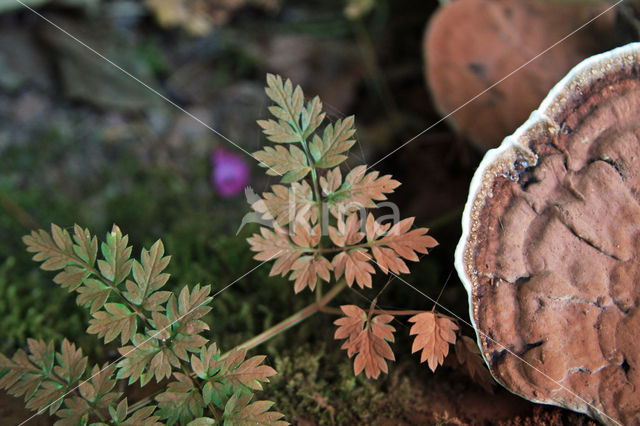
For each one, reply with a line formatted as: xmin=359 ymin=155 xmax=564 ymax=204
xmin=334 ymin=305 xmax=395 ymax=379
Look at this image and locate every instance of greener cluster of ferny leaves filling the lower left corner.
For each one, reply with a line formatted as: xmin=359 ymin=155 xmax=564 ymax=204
xmin=0 ymin=225 xmax=285 ymax=425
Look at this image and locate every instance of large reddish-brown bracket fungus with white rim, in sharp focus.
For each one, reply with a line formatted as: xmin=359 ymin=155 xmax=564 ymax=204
xmin=456 ymin=43 xmax=640 ymax=424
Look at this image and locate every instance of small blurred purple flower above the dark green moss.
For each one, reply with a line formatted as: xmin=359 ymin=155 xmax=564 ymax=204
xmin=211 ymin=148 xmax=249 ymax=197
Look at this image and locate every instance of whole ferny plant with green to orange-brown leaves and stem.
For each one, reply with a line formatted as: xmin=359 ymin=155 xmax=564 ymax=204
xmin=0 ymin=75 xmax=490 ymax=425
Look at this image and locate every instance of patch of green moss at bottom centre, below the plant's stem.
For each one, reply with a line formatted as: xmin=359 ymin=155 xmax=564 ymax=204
xmin=265 ymin=342 xmax=416 ymax=424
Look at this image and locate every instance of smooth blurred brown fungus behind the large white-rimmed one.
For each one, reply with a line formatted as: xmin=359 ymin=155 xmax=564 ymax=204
xmin=424 ymin=0 xmax=615 ymax=150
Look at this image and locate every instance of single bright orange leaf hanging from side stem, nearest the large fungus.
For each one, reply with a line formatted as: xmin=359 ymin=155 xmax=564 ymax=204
xmin=409 ymin=312 xmax=460 ymax=371
